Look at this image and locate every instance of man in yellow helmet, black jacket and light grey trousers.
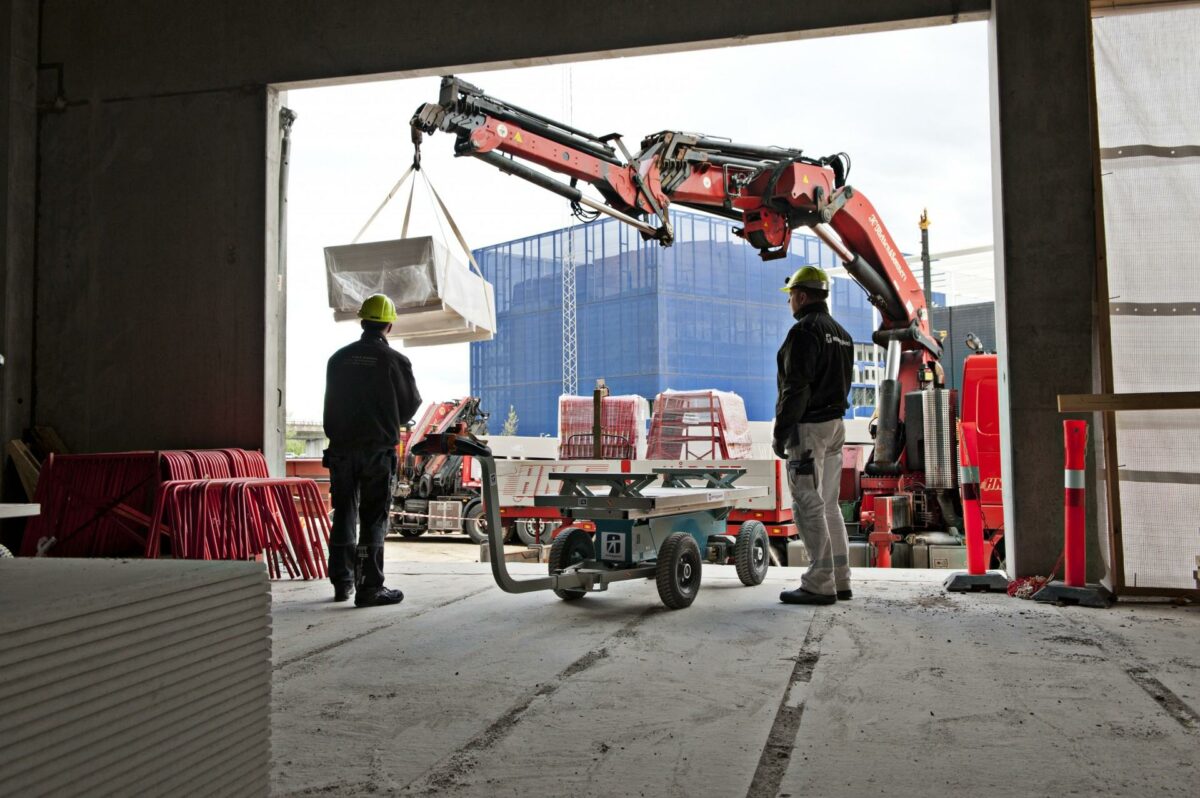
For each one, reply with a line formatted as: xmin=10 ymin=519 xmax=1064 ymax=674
xmin=772 ymin=266 xmax=854 ymax=604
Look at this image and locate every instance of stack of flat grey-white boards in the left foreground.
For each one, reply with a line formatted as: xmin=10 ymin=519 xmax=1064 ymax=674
xmin=0 ymin=559 xmax=271 ymax=796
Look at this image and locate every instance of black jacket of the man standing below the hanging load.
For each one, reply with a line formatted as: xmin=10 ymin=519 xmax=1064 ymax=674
xmin=324 ymin=331 xmax=421 ymax=451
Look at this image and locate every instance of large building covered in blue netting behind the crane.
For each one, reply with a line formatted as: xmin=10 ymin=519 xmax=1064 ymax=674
xmin=470 ymin=211 xmax=876 ymax=436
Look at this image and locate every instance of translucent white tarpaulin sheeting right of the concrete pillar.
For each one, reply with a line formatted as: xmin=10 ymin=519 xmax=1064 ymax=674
xmin=1092 ymin=7 xmax=1200 ymax=589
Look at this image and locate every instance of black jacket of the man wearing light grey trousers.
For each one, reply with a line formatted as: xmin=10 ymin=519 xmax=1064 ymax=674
xmin=775 ymin=301 xmax=854 ymax=445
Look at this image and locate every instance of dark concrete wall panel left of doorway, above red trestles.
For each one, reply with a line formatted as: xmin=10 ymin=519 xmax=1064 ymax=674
xmin=35 ymin=88 xmax=277 ymax=451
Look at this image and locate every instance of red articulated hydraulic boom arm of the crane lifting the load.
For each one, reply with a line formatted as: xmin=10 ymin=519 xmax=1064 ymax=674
xmin=412 ymin=77 xmax=942 ymax=362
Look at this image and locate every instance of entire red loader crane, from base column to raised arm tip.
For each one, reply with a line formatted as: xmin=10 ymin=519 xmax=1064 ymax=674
xmin=410 ymin=76 xmax=1001 ymax=563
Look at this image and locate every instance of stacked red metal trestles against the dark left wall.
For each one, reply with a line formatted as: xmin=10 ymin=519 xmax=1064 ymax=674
xmin=22 ymin=449 xmax=329 ymax=580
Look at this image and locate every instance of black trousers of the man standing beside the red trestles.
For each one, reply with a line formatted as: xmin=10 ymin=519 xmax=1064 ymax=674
xmin=329 ymin=449 xmax=397 ymax=592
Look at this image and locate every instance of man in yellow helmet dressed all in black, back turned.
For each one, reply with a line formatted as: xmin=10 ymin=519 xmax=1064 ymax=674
xmin=324 ymin=294 xmax=421 ymax=607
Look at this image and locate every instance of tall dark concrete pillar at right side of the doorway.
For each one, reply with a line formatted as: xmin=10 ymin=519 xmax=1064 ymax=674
xmin=990 ymin=0 xmax=1099 ymax=576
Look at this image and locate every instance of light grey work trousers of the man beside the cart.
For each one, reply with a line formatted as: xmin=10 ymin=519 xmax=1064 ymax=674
xmin=787 ymin=419 xmax=850 ymax=595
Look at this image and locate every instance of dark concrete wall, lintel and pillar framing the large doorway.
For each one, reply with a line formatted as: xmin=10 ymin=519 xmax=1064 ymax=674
xmin=0 ymin=0 xmax=1094 ymax=572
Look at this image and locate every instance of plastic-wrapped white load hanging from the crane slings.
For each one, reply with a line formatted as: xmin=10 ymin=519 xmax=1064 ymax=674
xmin=325 ymin=236 xmax=496 ymax=347
